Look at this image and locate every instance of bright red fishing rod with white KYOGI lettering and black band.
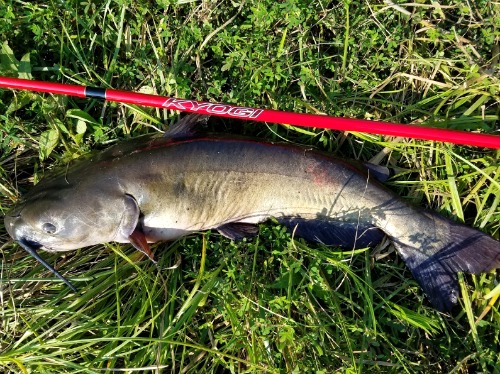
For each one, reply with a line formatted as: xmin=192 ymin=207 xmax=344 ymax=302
xmin=0 ymin=77 xmax=500 ymax=149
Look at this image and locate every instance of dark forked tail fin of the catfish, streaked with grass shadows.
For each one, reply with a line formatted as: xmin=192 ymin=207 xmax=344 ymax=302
xmin=394 ymin=214 xmax=500 ymax=311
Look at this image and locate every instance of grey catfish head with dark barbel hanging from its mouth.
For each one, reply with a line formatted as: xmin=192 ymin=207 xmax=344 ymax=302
xmin=5 ymin=183 xmax=142 ymax=291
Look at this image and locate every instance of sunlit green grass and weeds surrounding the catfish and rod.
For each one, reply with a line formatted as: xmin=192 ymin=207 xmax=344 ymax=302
xmin=0 ymin=0 xmax=500 ymax=373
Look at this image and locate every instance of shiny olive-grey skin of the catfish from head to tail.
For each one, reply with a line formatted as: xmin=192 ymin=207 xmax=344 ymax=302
xmin=5 ymin=116 xmax=500 ymax=310
